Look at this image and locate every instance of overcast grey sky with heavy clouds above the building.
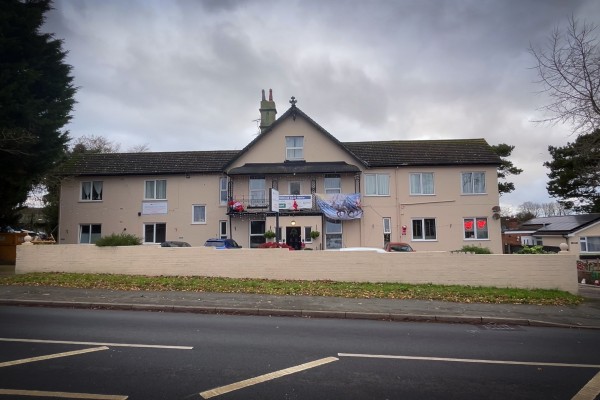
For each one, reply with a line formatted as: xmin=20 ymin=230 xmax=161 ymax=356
xmin=45 ymin=0 xmax=600 ymax=210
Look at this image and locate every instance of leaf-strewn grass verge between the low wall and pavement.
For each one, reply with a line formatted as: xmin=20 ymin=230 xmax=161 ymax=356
xmin=0 ymin=273 xmax=583 ymax=305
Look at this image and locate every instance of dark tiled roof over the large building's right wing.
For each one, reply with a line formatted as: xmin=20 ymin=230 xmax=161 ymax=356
xmin=343 ymin=139 xmax=501 ymax=168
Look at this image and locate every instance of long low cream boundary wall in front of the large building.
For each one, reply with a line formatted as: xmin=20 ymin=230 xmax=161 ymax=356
xmin=16 ymin=245 xmax=578 ymax=293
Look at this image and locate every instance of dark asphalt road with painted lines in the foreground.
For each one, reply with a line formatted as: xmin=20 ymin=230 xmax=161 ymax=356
xmin=0 ymin=307 xmax=600 ymax=400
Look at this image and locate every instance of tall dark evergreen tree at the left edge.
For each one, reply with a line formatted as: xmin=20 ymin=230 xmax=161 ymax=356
xmin=0 ymin=0 xmax=76 ymax=227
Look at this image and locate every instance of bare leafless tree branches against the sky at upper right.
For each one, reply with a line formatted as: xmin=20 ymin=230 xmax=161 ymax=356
xmin=529 ymin=17 xmax=600 ymax=134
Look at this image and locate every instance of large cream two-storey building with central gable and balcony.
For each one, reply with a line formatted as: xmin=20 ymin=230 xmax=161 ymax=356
xmin=59 ymin=92 xmax=502 ymax=253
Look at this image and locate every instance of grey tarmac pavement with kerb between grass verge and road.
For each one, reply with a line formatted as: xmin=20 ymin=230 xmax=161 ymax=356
xmin=0 ymin=285 xmax=600 ymax=330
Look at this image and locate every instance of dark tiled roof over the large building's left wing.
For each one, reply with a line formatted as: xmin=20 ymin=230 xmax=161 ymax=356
xmin=59 ymin=150 xmax=238 ymax=176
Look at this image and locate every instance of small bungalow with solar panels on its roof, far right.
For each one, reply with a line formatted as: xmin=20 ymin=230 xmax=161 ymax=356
xmin=504 ymin=214 xmax=600 ymax=258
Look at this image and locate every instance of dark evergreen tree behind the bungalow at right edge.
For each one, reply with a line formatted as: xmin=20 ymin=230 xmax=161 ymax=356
xmin=544 ymin=129 xmax=600 ymax=213
